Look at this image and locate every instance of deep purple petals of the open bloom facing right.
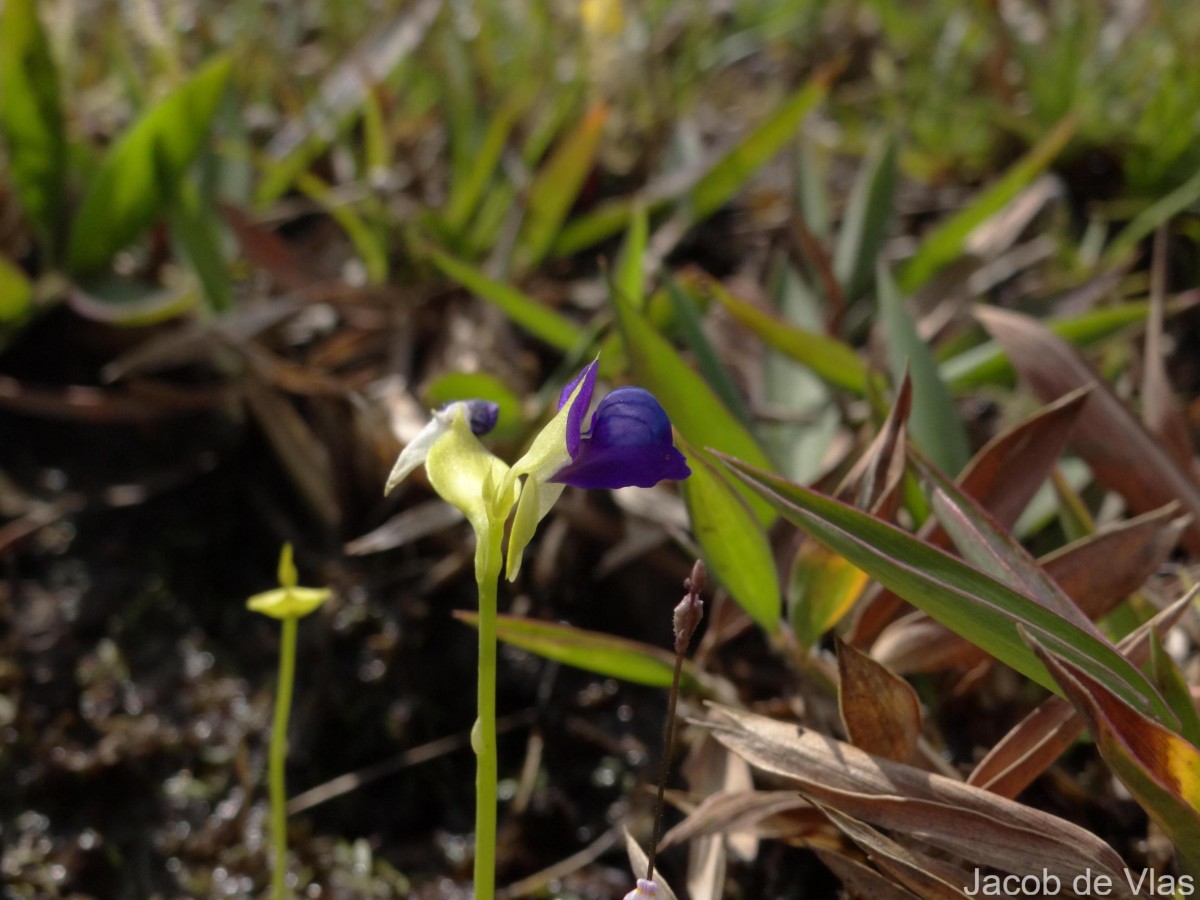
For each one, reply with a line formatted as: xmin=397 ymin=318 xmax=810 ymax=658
xmin=547 ymin=362 xmax=691 ymax=488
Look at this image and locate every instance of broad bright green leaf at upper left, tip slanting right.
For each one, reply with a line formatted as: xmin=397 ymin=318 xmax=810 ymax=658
xmin=67 ymin=58 xmax=230 ymax=274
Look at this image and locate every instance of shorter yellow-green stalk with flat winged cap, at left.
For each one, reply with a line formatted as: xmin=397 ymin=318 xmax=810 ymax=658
xmin=246 ymin=544 xmax=330 ymax=900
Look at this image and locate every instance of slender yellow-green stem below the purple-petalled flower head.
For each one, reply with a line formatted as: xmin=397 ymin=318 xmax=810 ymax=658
xmin=472 ymin=528 xmax=504 ymax=900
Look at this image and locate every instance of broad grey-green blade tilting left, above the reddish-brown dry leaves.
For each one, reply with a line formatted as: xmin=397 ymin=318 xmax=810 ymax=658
xmin=875 ymin=263 xmax=971 ymax=474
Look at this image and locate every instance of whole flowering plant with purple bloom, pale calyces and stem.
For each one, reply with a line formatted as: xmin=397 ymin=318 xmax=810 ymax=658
xmin=384 ymin=362 xmax=690 ymax=900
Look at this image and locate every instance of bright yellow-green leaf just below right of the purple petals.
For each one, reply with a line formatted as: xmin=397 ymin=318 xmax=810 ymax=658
xmin=679 ymin=438 xmax=782 ymax=634
